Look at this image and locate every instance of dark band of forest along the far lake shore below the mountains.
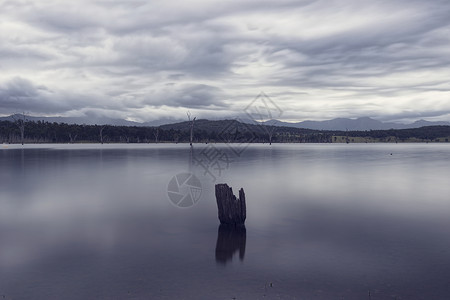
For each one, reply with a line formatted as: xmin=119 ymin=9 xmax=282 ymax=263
xmin=0 ymin=120 xmax=450 ymax=143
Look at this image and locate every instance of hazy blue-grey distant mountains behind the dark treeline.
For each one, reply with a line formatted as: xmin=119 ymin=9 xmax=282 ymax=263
xmin=0 ymin=116 xmax=450 ymax=131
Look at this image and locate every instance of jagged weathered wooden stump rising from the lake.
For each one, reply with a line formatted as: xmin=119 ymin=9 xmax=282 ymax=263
xmin=216 ymin=183 xmax=247 ymax=225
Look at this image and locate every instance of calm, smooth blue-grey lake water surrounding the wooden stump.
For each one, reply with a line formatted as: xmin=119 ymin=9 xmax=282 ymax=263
xmin=0 ymin=144 xmax=450 ymax=300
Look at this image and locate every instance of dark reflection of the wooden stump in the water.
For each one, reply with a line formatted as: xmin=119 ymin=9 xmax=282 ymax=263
xmin=216 ymin=224 xmax=247 ymax=264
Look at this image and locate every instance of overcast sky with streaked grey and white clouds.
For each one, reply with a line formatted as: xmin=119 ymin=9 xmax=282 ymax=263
xmin=0 ymin=0 xmax=450 ymax=121
